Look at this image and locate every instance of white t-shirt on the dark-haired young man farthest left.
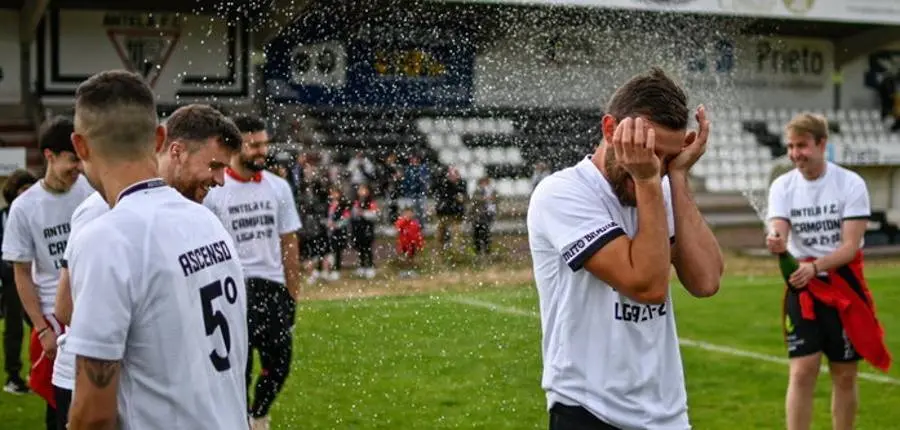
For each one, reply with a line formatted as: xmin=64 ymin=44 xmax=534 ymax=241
xmin=3 ymin=175 xmax=94 ymax=315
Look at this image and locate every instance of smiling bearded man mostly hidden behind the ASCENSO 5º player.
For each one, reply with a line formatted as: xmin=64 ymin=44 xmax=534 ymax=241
xmin=53 ymin=104 xmax=241 ymax=430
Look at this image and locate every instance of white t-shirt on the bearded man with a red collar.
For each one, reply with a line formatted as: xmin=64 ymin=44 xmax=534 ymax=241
xmin=203 ymin=171 xmax=301 ymax=284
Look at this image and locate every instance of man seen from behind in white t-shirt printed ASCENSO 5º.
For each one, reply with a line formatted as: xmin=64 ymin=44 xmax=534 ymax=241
xmin=65 ymin=71 xmax=248 ymax=430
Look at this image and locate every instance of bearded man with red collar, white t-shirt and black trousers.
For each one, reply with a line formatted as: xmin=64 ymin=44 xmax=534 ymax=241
xmin=203 ymin=115 xmax=301 ymax=429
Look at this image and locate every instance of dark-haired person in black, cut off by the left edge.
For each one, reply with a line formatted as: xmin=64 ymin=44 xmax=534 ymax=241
xmin=0 ymin=169 xmax=37 ymax=394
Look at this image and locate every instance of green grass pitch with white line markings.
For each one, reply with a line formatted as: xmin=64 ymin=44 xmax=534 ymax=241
xmin=0 ymin=268 xmax=900 ymax=430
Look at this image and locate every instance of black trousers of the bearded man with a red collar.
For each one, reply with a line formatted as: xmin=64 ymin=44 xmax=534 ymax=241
xmin=247 ymin=278 xmax=296 ymax=418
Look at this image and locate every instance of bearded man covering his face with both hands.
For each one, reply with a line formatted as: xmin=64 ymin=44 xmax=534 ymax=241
xmin=527 ymin=69 xmax=723 ymax=430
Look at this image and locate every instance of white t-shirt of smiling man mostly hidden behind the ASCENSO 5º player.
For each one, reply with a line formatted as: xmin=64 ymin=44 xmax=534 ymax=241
xmin=53 ymin=191 xmax=109 ymax=390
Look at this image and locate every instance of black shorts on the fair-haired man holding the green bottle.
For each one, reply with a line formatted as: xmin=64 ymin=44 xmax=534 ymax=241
xmin=784 ymin=280 xmax=862 ymax=362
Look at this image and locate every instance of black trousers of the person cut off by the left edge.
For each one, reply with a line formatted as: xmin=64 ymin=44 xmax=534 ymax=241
xmin=0 ymin=263 xmax=31 ymax=379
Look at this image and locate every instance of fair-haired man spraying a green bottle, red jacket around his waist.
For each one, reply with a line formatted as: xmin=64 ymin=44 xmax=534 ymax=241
xmin=766 ymin=114 xmax=891 ymax=430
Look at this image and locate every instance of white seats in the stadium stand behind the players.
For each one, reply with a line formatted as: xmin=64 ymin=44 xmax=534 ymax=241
xmin=396 ymin=108 xmax=900 ymax=197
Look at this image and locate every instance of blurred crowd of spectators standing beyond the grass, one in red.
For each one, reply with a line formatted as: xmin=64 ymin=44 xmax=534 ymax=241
xmin=268 ymin=150 xmax=497 ymax=283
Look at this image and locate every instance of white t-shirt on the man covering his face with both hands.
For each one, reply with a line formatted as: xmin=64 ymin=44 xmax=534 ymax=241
xmin=527 ymin=157 xmax=691 ymax=430
